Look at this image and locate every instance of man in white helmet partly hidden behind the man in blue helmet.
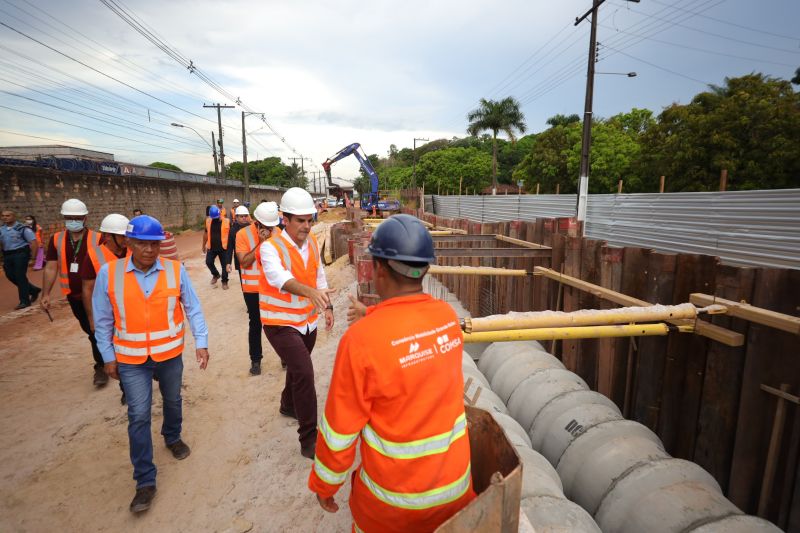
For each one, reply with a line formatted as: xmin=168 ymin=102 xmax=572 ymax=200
xmin=78 ymin=213 xmax=128 ymax=392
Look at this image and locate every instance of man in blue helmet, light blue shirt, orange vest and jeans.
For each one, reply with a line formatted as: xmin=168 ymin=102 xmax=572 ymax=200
xmin=92 ymin=215 xmax=209 ymax=513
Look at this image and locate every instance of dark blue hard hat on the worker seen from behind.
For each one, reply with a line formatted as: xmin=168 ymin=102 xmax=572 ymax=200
xmin=367 ymin=215 xmax=436 ymax=264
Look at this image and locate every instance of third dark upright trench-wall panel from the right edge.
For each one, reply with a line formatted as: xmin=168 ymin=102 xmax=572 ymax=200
xmin=659 ymin=254 xmax=719 ymax=459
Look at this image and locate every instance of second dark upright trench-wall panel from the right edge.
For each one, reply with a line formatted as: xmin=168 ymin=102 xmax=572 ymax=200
xmin=692 ymin=265 xmax=755 ymax=492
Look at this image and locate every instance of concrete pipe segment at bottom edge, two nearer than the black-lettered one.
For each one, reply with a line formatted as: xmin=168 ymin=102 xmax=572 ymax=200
xmin=595 ymin=458 xmax=741 ymax=533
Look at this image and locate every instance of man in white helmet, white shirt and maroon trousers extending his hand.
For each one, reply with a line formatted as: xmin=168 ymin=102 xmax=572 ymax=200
xmin=258 ymin=187 xmax=333 ymax=459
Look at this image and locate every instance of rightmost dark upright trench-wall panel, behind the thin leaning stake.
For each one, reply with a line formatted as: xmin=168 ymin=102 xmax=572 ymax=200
xmin=728 ymin=268 xmax=800 ymax=519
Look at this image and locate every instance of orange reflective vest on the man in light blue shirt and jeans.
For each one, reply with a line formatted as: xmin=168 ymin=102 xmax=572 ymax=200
xmin=108 ymin=258 xmax=184 ymax=365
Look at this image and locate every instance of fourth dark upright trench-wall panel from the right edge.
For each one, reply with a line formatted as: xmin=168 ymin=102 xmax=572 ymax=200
xmin=632 ymin=252 xmax=676 ymax=431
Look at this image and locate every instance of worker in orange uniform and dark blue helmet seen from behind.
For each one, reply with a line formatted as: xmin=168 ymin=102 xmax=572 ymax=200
xmin=308 ymin=215 xmax=475 ymax=532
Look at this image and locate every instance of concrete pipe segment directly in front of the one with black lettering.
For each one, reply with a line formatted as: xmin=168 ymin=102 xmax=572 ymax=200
xmin=556 ymin=420 xmax=670 ymax=514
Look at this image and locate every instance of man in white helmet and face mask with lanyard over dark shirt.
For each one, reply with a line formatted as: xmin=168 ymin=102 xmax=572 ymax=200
xmin=39 ymin=198 xmax=108 ymax=386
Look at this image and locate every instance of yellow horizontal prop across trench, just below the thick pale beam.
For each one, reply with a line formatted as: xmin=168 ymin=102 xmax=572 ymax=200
xmin=464 ymin=324 xmax=694 ymax=342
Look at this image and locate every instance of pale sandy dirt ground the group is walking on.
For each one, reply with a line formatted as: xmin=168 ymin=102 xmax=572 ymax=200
xmin=0 ymin=217 xmax=354 ymax=532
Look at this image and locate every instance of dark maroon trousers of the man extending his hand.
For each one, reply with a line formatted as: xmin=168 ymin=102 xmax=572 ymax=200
xmin=264 ymin=326 xmax=317 ymax=447
